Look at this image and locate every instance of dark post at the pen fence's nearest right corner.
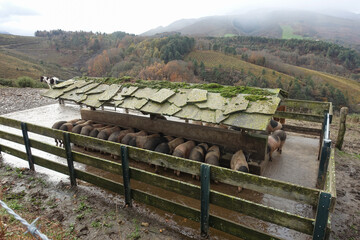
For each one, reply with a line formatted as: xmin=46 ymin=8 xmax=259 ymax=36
xmin=313 ymin=192 xmax=331 ymax=240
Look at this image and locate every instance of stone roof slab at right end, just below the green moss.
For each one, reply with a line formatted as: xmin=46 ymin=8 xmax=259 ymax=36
xmin=245 ymin=96 xmax=281 ymax=114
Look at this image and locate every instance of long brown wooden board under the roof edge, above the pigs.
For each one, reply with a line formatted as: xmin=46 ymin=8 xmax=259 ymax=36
xmin=81 ymin=109 xmax=267 ymax=160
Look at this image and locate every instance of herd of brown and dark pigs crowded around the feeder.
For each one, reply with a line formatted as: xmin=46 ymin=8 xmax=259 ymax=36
xmin=52 ymin=119 xmax=286 ymax=191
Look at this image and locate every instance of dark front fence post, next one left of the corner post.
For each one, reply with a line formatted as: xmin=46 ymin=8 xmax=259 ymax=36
xmin=200 ymin=164 xmax=210 ymax=237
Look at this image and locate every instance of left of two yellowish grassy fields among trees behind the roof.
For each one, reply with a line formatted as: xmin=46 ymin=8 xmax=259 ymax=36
xmin=186 ymin=51 xmax=294 ymax=84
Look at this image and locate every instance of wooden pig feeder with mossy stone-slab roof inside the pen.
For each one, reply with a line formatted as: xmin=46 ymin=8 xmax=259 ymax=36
xmin=43 ymin=79 xmax=287 ymax=175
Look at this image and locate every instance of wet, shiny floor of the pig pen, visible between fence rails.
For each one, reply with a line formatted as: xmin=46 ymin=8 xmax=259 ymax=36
xmin=0 ymin=104 xmax=319 ymax=239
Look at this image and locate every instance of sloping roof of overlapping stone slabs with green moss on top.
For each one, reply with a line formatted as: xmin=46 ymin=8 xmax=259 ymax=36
xmin=43 ymin=79 xmax=287 ymax=130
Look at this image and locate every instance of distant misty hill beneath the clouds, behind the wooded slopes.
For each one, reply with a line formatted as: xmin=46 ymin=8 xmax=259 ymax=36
xmin=142 ymin=10 xmax=360 ymax=51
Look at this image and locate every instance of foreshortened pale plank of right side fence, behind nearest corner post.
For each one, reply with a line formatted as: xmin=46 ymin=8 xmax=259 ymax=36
xmin=325 ymin=149 xmax=336 ymax=212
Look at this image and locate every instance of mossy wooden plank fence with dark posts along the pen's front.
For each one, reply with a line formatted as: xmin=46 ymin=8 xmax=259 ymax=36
xmin=0 ymin=117 xmax=336 ymax=239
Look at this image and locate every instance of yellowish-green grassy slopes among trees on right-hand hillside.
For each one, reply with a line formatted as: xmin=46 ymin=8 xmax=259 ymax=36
xmin=187 ymin=51 xmax=360 ymax=105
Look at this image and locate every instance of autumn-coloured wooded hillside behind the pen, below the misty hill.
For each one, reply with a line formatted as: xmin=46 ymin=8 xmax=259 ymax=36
xmin=2 ymin=30 xmax=360 ymax=112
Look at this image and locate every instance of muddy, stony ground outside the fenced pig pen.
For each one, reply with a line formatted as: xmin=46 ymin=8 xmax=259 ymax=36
xmin=0 ymin=88 xmax=360 ymax=240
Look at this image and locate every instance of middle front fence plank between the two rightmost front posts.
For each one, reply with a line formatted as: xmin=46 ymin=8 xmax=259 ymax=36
xmin=210 ymin=191 xmax=315 ymax=235
